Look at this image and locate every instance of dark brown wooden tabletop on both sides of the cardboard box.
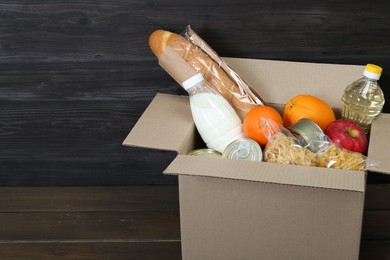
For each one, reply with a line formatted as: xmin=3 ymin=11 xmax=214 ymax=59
xmin=0 ymin=185 xmax=390 ymax=260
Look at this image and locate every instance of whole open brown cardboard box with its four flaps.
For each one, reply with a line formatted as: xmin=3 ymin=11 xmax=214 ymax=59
xmin=123 ymin=58 xmax=390 ymax=260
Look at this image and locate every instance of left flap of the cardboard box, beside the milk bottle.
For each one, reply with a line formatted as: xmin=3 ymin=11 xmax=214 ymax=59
xmin=123 ymin=94 xmax=196 ymax=152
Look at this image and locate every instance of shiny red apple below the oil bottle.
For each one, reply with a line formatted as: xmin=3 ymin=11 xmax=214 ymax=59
xmin=325 ymin=119 xmax=368 ymax=154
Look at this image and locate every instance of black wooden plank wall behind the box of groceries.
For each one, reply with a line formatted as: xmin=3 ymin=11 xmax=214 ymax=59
xmin=0 ymin=0 xmax=390 ymax=186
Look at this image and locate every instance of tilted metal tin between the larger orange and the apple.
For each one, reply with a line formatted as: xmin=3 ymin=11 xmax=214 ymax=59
xmin=288 ymin=118 xmax=325 ymax=152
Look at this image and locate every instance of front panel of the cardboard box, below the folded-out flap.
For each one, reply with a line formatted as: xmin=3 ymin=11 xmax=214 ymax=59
xmin=179 ymin=176 xmax=364 ymax=260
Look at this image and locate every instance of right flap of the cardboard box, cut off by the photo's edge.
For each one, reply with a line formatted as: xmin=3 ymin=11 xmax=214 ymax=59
xmin=367 ymin=113 xmax=390 ymax=174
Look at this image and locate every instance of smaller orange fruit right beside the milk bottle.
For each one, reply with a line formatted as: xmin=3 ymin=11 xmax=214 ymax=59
xmin=242 ymin=106 xmax=283 ymax=146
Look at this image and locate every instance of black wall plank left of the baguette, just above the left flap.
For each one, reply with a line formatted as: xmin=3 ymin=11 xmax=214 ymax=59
xmin=0 ymin=60 xmax=179 ymax=101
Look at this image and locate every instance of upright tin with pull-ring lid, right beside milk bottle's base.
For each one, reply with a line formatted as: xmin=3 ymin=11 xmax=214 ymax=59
xmin=222 ymin=138 xmax=263 ymax=161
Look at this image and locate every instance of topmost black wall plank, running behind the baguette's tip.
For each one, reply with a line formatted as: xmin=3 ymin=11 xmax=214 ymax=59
xmin=0 ymin=0 xmax=389 ymax=62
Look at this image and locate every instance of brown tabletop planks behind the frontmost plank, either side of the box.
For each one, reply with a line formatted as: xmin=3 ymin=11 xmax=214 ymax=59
xmin=0 ymin=185 xmax=390 ymax=243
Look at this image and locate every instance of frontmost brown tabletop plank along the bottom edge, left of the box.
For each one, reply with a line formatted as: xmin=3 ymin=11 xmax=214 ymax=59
xmin=0 ymin=241 xmax=181 ymax=260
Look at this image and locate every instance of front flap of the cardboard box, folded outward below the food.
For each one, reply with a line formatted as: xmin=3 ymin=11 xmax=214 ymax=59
xmin=164 ymin=155 xmax=365 ymax=192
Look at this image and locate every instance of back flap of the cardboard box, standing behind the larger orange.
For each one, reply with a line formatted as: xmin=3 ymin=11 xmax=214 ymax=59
xmin=224 ymin=58 xmax=364 ymax=108
